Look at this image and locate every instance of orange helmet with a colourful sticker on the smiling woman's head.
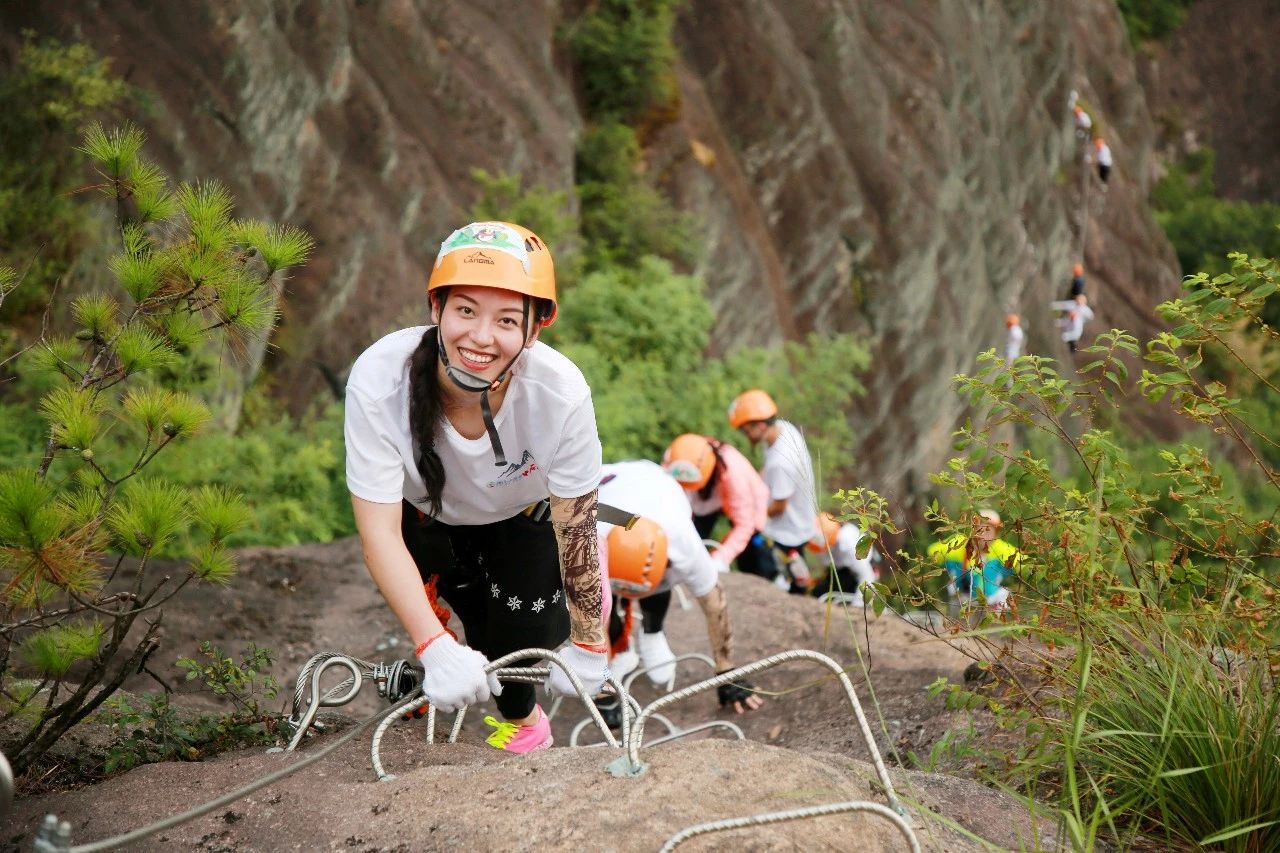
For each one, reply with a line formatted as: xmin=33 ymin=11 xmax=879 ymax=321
xmin=426 ymin=222 xmax=557 ymax=325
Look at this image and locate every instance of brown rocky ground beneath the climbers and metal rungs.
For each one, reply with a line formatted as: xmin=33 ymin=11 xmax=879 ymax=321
xmin=0 ymin=540 xmax=1052 ymax=852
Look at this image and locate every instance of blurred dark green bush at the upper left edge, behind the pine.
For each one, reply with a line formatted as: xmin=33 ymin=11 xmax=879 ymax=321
xmin=0 ymin=32 xmax=127 ymax=318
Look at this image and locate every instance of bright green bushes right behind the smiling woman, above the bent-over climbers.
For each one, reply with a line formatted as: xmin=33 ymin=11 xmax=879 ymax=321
xmin=547 ymin=257 xmax=868 ymax=481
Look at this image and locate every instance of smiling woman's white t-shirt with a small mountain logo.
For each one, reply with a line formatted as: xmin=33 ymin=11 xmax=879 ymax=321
xmin=346 ymin=325 xmax=600 ymax=525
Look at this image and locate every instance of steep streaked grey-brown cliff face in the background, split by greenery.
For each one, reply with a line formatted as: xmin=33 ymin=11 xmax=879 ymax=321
xmin=0 ymin=0 xmax=1176 ymax=498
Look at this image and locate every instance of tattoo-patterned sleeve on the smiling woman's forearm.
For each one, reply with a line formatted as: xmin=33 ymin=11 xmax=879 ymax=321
xmin=552 ymin=489 xmax=608 ymax=647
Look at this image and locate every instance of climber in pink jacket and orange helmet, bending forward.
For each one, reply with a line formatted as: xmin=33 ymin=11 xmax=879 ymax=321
xmin=662 ymin=433 xmax=778 ymax=580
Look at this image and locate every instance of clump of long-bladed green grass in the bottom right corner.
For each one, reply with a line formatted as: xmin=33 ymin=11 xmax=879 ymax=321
xmin=1039 ymin=620 xmax=1280 ymax=853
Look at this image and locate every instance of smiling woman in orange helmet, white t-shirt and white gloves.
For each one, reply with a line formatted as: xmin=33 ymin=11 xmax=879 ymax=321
xmin=346 ymin=222 xmax=608 ymax=752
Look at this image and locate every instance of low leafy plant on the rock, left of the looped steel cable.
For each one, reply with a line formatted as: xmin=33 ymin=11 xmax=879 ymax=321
xmin=97 ymin=643 xmax=279 ymax=774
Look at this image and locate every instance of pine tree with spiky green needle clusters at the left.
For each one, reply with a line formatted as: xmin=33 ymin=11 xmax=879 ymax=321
xmin=0 ymin=126 xmax=309 ymax=774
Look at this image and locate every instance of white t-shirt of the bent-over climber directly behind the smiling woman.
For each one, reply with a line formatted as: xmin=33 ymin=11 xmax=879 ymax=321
xmin=596 ymin=460 xmax=719 ymax=597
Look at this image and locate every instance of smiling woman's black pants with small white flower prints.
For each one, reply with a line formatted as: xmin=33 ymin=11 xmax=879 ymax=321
xmin=401 ymin=502 xmax=568 ymax=720
